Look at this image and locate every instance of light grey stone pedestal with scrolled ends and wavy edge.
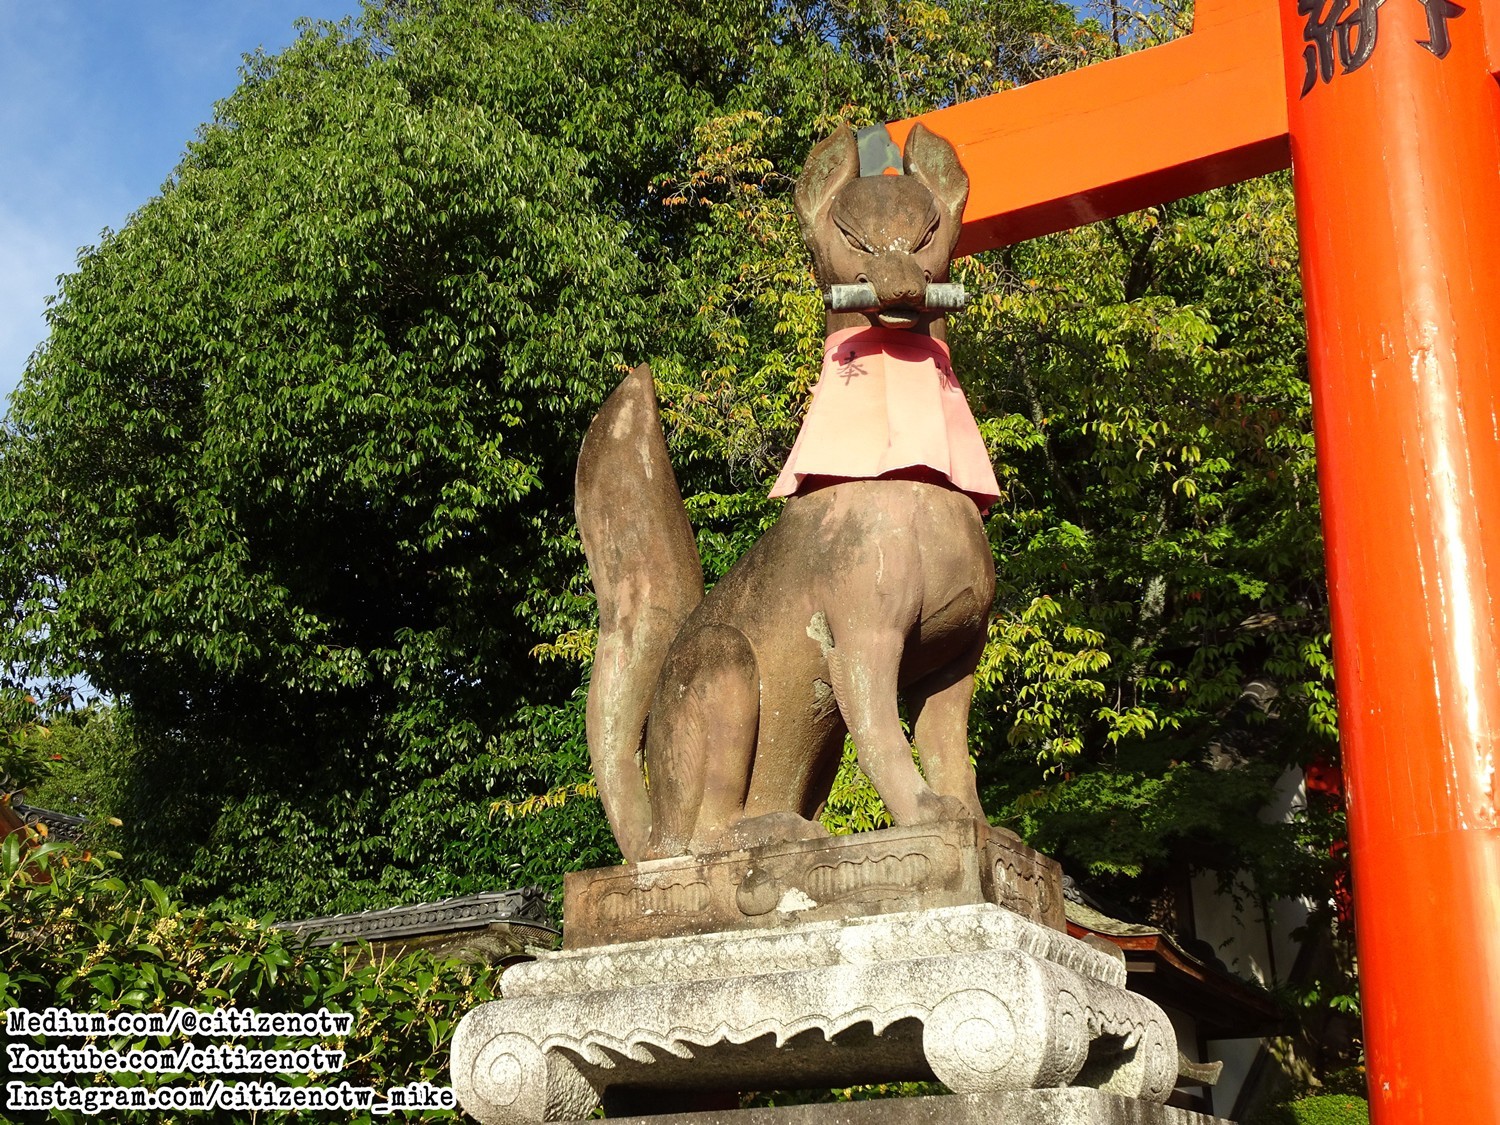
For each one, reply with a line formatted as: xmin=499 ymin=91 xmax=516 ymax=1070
xmin=453 ymin=905 xmax=1178 ymax=1125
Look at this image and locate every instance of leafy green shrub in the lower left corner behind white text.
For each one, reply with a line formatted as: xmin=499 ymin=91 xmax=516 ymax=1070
xmin=0 ymin=834 xmax=497 ymax=1125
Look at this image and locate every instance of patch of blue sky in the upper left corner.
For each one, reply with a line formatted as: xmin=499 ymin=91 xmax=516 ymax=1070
xmin=0 ymin=0 xmax=359 ymax=396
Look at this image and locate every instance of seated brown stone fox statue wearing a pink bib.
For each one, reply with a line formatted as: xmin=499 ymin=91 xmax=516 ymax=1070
xmin=578 ymin=125 xmax=999 ymax=861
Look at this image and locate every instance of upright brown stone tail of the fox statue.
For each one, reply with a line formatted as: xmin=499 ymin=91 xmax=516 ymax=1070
xmin=575 ymin=363 xmax=704 ymax=863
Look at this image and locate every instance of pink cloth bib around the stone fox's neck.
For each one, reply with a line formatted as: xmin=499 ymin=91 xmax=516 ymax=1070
xmin=771 ymin=329 xmax=1001 ymax=512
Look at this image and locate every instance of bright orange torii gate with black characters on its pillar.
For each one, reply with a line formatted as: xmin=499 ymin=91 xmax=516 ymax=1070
xmin=891 ymin=0 xmax=1500 ymax=1125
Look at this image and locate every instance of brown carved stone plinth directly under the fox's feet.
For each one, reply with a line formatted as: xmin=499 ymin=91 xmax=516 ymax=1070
xmin=563 ymin=821 xmax=1067 ymax=950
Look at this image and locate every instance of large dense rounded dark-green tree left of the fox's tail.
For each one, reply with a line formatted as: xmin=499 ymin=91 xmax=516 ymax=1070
xmin=0 ymin=5 xmax=666 ymax=911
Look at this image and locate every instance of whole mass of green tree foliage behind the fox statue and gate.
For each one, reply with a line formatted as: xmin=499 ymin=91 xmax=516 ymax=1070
xmin=0 ymin=0 xmax=1338 ymax=972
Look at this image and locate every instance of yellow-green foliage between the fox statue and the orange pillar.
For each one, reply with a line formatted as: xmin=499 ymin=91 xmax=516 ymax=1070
xmin=959 ymin=180 xmax=1335 ymax=890
